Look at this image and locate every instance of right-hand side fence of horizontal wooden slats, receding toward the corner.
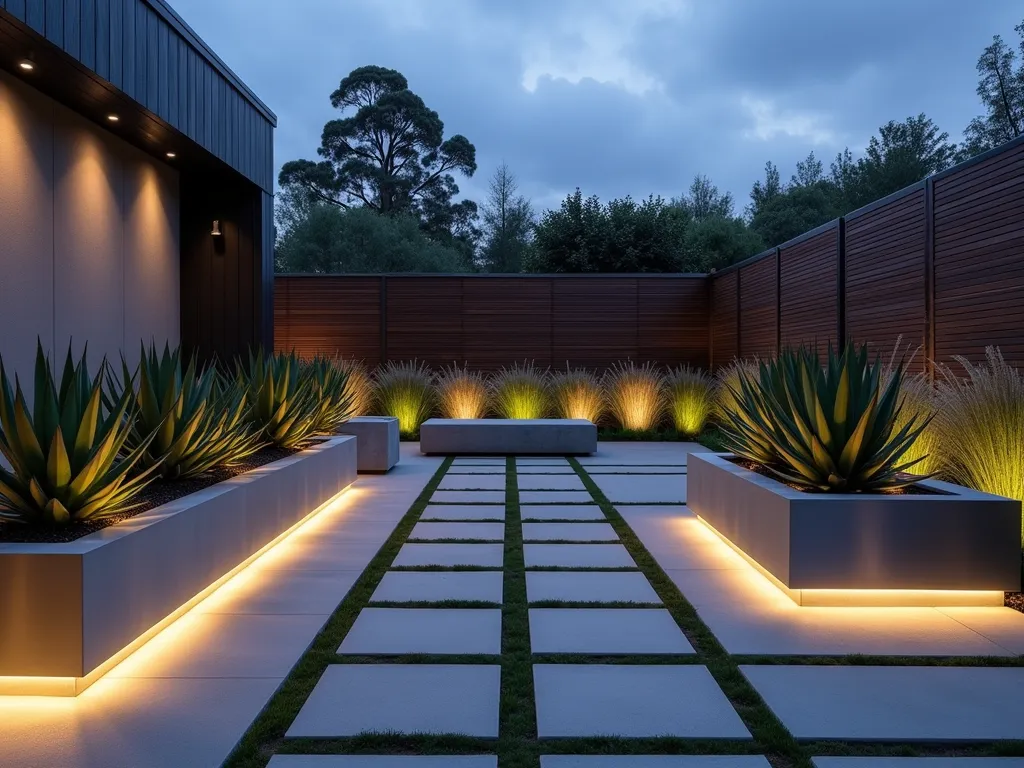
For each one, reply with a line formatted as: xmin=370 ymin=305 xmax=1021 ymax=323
xmin=711 ymin=137 xmax=1024 ymax=371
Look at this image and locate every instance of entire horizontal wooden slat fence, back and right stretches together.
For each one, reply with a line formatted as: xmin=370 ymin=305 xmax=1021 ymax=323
xmin=274 ymin=137 xmax=1024 ymax=371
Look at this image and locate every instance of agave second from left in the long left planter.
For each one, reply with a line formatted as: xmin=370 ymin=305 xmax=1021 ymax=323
xmin=108 ymin=344 xmax=262 ymax=479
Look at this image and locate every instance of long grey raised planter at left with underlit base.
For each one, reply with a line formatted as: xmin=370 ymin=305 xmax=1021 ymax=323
xmin=0 ymin=435 xmax=356 ymax=695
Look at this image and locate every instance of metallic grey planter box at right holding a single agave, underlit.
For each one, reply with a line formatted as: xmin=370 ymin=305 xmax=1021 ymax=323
xmin=687 ymin=454 xmax=1021 ymax=605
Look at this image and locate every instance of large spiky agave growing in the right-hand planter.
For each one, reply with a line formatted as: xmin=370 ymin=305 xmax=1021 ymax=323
xmin=723 ymin=344 xmax=927 ymax=493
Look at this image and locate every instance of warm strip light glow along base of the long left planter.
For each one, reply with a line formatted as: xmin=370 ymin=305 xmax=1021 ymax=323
xmin=0 ymin=486 xmax=366 ymax=707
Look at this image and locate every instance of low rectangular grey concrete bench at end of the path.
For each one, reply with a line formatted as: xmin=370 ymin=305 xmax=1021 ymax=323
xmin=420 ymin=419 xmax=597 ymax=456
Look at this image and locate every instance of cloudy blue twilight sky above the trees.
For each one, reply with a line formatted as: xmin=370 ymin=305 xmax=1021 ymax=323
xmin=171 ymin=0 xmax=1024 ymax=213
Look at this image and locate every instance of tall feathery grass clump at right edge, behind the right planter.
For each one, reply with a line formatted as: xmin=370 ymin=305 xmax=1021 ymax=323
xmin=935 ymin=347 xmax=1024 ymax=540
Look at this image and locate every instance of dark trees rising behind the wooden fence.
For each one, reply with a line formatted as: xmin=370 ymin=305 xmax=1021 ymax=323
xmin=275 ymin=22 xmax=1024 ymax=272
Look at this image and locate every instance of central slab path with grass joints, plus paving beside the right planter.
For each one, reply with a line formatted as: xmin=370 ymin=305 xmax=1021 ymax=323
xmin=239 ymin=444 xmax=1024 ymax=768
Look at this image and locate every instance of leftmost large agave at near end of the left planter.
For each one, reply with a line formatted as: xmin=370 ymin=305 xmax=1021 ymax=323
xmin=0 ymin=345 xmax=155 ymax=525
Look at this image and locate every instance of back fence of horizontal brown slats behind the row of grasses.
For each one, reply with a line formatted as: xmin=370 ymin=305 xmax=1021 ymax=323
xmin=274 ymin=274 xmax=710 ymax=371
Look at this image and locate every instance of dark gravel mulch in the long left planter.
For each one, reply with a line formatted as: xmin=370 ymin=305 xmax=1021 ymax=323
xmin=0 ymin=446 xmax=296 ymax=544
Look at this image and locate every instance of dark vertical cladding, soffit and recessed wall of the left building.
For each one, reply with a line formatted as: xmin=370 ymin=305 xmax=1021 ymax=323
xmin=0 ymin=0 xmax=276 ymax=358
